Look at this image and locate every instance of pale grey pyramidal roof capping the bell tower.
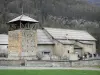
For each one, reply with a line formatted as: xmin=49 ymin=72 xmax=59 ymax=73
xmin=8 ymin=14 xmax=39 ymax=23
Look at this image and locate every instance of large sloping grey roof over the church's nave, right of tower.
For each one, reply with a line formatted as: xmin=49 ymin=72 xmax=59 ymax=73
xmin=44 ymin=28 xmax=96 ymax=40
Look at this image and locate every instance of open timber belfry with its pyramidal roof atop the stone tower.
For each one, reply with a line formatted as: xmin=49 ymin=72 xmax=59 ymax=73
xmin=8 ymin=14 xmax=38 ymax=30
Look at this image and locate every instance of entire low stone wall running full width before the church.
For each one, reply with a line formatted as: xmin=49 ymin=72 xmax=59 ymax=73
xmin=0 ymin=59 xmax=100 ymax=67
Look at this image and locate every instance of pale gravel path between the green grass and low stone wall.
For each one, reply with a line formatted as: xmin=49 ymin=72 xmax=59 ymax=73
xmin=0 ymin=66 xmax=100 ymax=71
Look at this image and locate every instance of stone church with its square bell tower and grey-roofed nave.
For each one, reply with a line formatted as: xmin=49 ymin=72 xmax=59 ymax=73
xmin=8 ymin=15 xmax=96 ymax=60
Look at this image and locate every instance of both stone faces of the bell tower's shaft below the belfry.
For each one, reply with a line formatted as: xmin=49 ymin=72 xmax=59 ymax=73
xmin=8 ymin=30 xmax=37 ymax=59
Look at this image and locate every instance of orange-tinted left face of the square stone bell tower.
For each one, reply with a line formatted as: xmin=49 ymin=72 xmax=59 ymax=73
xmin=8 ymin=30 xmax=21 ymax=57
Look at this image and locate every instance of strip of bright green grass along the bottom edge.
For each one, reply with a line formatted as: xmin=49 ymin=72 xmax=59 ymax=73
xmin=0 ymin=70 xmax=100 ymax=75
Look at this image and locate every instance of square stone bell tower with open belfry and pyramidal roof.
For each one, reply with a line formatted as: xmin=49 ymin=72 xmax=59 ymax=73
xmin=8 ymin=14 xmax=38 ymax=60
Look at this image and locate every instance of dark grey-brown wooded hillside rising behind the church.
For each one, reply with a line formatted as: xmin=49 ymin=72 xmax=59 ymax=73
xmin=0 ymin=0 xmax=100 ymax=54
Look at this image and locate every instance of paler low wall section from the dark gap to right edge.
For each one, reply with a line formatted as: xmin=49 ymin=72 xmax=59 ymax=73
xmin=26 ymin=60 xmax=100 ymax=67
